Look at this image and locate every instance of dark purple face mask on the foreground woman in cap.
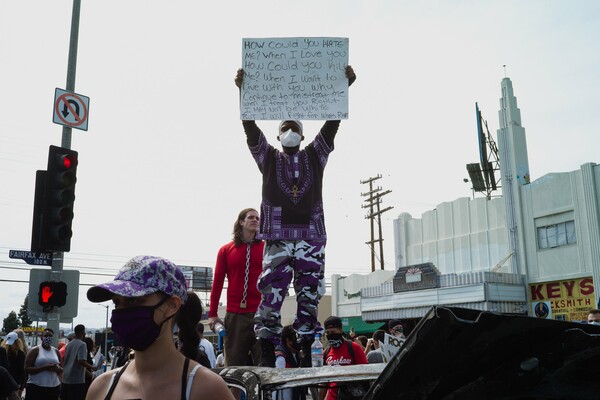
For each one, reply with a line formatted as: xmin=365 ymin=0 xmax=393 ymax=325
xmin=110 ymin=297 xmax=174 ymax=351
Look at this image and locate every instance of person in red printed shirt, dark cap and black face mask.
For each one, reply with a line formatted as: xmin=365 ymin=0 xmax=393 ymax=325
xmin=319 ymin=315 xmax=368 ymax=400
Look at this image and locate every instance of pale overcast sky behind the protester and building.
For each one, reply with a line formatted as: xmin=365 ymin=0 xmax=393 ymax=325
xmin=0 ymin=0 xmax=600 ymax=327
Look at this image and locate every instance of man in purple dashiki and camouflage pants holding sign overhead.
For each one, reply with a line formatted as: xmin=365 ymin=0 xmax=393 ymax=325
xmin=235 ymin=66 xmax=356 ymax=367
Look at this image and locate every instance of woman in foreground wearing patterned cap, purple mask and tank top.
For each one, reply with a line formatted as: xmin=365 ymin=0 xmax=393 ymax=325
xmin=86 ymin=256 xmax=233 ymax=400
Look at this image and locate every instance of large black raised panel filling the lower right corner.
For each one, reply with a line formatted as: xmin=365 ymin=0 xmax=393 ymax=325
xmin=364 ymin=307 xmax=600 ymax=400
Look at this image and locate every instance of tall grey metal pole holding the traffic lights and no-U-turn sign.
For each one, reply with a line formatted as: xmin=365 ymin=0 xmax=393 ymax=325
xmin=47 ymin=0 xmax=81 ymax=346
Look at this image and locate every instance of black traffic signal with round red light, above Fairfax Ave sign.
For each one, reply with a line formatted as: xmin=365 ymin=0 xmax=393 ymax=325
xmin=32 ymin=146 xmax=78 ymax=251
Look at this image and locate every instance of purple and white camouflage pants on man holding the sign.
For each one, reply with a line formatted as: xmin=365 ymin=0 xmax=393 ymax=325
xmin=254 ymin=240 xmax=325 ymax=345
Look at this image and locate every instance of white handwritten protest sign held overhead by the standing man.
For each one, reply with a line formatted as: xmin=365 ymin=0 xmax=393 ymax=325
xmin=240 ymin=37 xmax=348 ymax=120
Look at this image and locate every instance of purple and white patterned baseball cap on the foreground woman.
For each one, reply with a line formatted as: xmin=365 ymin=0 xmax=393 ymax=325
xmin=87 ymin=256 xmax=187 ymax=303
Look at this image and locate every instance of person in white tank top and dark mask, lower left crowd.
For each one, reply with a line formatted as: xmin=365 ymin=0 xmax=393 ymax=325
xmin=25 ymin=328 xmax=62 ymax=400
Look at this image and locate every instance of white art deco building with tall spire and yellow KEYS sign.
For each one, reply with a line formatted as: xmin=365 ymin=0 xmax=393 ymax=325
xmin=332 ymin=78 xmax=600 ymax=321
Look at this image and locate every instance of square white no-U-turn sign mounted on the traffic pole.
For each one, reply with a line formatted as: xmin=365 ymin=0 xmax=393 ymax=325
xmin=52 ymin=88 xmax=90 ymax=131
